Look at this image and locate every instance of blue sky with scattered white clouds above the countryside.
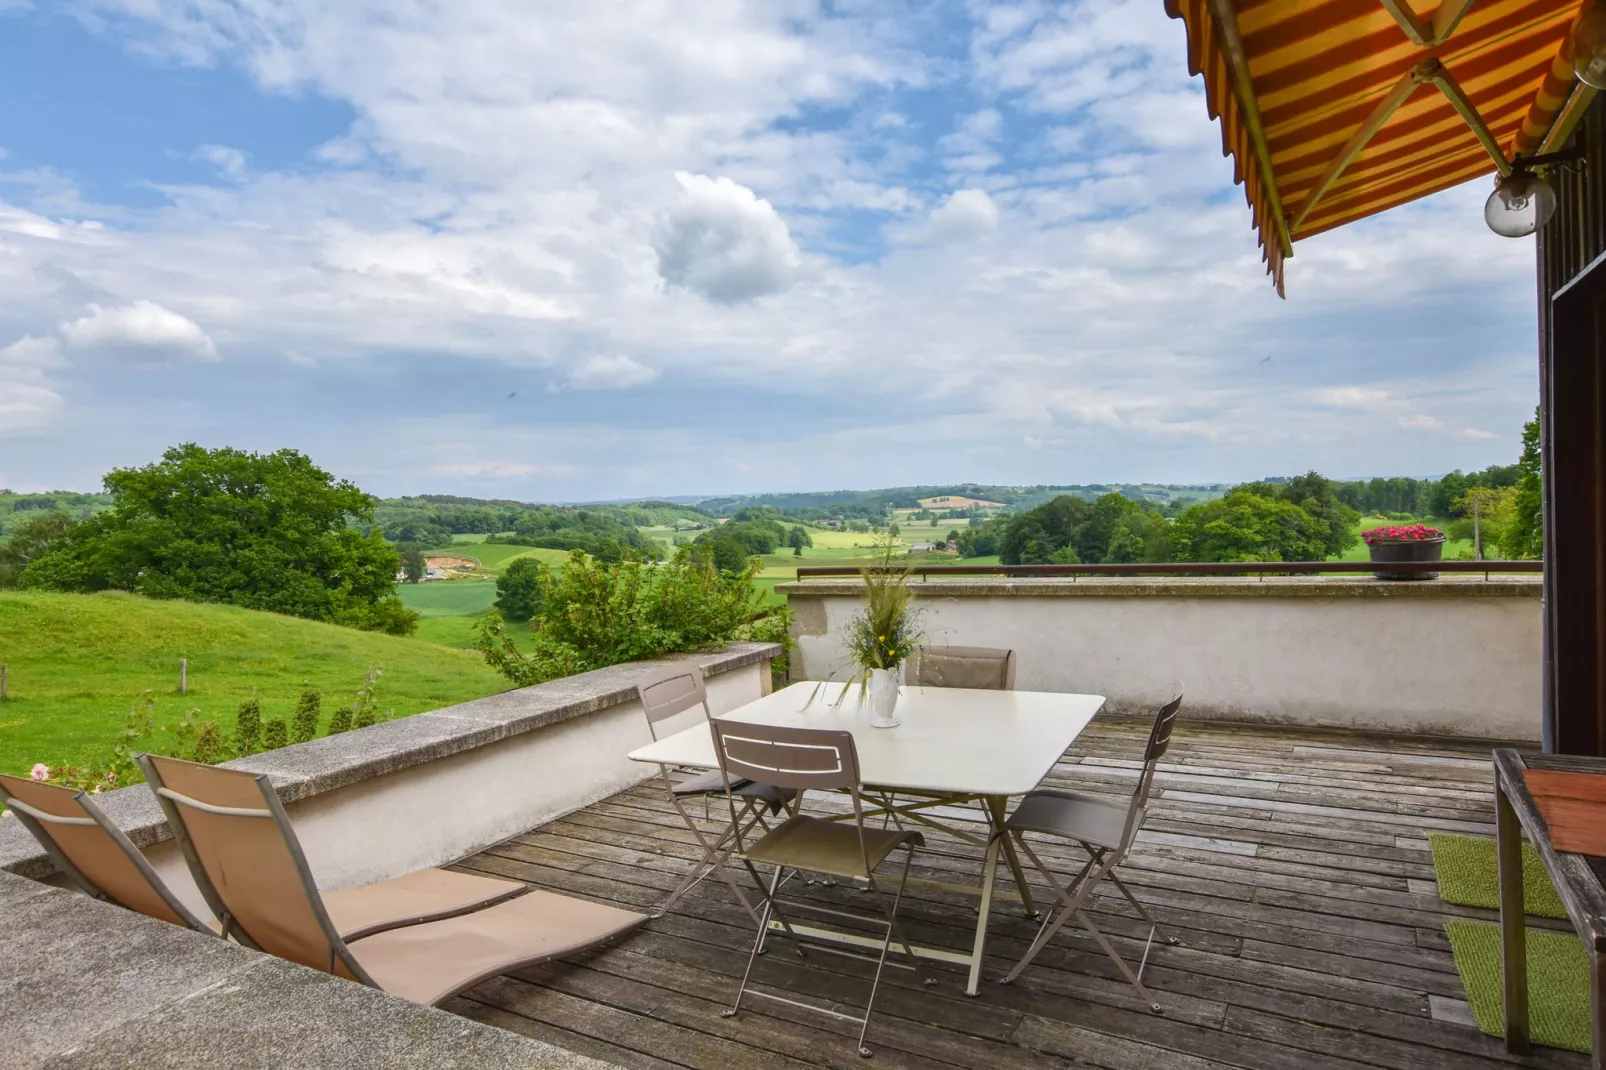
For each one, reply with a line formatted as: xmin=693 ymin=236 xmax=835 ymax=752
xmin=0 ymin=0 xmax=1537 ymax=500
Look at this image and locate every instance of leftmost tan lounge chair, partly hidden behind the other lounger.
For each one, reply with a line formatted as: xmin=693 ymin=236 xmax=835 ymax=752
xmin=0 ymin=774 xmax=528 ymax=940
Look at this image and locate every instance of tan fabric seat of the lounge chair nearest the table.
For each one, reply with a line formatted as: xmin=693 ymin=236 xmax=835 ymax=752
xmin=350 ymin=890 xmax=647 ymax=1004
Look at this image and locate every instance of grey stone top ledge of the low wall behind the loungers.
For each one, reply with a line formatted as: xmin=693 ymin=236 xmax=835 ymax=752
xmin=0 ymin=643 xmax=781 ymax=879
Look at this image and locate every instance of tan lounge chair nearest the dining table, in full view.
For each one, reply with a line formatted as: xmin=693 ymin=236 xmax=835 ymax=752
xmin=140 ymin=755 xmax=647 ymax=1004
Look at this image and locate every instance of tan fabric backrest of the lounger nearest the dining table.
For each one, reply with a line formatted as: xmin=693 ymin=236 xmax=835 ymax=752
xmin=140 ymin=753 xmax=374 ymax=985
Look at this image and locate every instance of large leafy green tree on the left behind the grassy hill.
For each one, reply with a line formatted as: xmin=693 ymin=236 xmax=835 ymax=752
xmin=21 ymin=443 xmax=418 ymax=635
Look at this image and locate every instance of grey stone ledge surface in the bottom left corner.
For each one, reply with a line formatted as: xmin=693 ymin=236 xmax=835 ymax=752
xmin=0 ymin=872 xmax=610 ymax=1070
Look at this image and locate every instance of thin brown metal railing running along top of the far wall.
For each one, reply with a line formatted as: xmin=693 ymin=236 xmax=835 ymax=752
xmin=798 ymin=561 xmax=1545 ymax=580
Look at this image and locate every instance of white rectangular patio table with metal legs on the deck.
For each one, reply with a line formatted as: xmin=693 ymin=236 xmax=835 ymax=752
xmin=630 ymin=681 xmax=1105 ymax=996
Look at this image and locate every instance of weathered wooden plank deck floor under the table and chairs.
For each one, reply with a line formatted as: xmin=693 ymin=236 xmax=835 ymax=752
xmin=448 ymin=718 xmax=1587 ymax=1070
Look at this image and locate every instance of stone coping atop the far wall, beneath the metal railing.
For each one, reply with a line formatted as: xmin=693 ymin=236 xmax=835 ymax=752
xmin=776 ymin=572 xmax=1543 ymax=599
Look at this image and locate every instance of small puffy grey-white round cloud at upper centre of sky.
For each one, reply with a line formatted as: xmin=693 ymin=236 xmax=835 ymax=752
xmin=652 ymin=172 xmax=800 ymax=305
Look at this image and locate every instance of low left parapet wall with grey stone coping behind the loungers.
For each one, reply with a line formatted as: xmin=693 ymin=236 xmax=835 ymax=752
xmin=0 ymin=643 xmax=781 ymax=917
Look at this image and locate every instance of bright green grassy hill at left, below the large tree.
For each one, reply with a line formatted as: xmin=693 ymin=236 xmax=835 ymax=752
xmin=0 ymin=591 xmax=507 ymax=773
